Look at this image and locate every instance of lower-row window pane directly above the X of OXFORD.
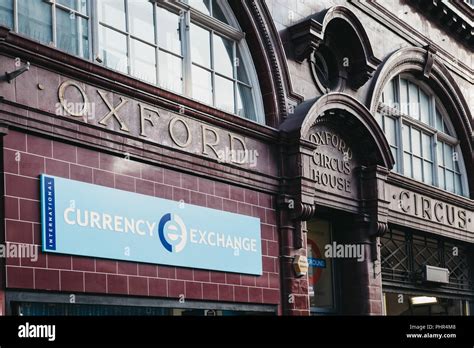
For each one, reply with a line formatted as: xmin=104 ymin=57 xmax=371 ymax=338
xmin=99 ymin=26 xmax=128 ymax=73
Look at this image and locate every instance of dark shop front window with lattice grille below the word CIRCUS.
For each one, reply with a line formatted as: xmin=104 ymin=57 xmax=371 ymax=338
xmin=380 ymin=230 xmax=474 ymax=315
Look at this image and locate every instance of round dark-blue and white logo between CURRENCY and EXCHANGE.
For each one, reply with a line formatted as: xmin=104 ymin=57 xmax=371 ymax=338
xmin=158 ymin=213 xmax=188 ymax=253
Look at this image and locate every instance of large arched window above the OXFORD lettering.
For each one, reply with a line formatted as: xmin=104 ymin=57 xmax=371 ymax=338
xmin=0 ymin=0 xmax=264 ymax=123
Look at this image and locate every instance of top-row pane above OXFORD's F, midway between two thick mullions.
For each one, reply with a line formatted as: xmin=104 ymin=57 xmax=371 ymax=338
xmin=128 ymin=0 xmax=155 ymax=43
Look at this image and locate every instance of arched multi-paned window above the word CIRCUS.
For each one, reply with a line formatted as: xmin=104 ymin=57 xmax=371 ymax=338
xmin=376 ymin=75 xmax=468 ymax=196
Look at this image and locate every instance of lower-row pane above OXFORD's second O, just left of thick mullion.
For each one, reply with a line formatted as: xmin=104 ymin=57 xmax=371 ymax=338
xmin=158 ymin=51 xmax=183 ymax=93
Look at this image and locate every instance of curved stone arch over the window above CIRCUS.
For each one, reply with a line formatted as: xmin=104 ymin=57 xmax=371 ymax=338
xmin=366 ymin=47 xmax=474 ymax=198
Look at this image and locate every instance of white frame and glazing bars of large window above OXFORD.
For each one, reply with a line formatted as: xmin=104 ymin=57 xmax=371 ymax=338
xmin=1 ymin=0 xmax=266 ymax=125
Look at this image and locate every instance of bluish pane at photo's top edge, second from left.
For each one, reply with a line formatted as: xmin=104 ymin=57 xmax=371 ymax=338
xmin=18 ymin=0 xmax=53 ymax=44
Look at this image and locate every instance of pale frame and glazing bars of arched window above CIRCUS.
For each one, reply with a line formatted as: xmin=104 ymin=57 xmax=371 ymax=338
xmin=377 ymin=73 xmax=469 ymax=197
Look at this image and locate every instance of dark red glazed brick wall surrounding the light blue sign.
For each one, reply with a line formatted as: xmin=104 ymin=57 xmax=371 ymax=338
xmin=4 ymin=131 xmax=280 ymax=304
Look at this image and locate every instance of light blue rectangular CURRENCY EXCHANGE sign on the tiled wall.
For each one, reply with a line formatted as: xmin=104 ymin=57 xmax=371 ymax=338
xmin=41 ymin=175 xmax=262 ymax=275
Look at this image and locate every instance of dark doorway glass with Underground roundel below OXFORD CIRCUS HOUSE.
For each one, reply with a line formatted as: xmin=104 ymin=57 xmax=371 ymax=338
xmin=307 ymin=219 xmax=336 ymax=313
